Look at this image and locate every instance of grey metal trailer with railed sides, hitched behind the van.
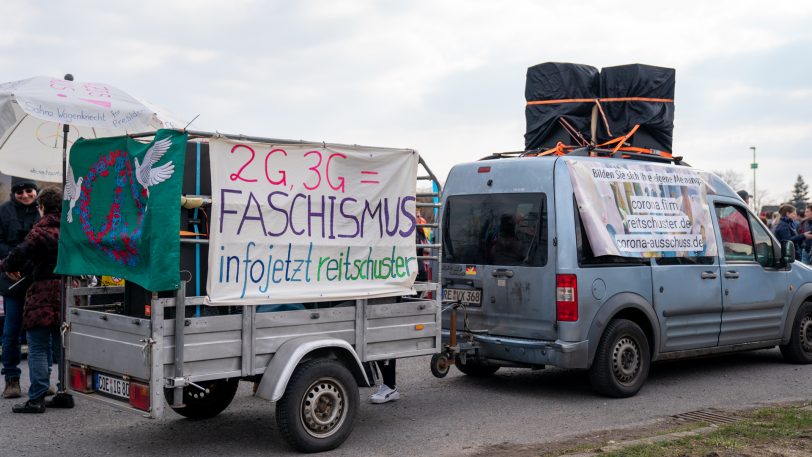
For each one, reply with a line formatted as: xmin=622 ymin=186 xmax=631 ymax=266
xmin=64 ymin=132 xmax=441 ymax=452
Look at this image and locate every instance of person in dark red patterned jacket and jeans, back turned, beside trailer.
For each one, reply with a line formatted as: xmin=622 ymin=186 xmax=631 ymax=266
xmin=0 ymin=189 xmax=62 ymax=413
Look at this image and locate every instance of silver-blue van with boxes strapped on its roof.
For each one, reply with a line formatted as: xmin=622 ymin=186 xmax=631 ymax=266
xmin=435 ymin=150 xmax=812 ymax=397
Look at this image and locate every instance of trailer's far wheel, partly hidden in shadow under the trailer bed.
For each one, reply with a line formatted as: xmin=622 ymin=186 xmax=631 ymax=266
xmin=164 ymin=378 xmax=240 ymax=420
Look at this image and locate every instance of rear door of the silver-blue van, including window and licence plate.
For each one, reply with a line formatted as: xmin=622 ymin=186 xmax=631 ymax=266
xmin=443 ymin=193 xmax=556 ymax=339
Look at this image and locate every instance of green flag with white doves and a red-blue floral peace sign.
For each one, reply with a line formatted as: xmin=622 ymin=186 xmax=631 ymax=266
xmin=55 ymin=130 xmax=187 ymax=291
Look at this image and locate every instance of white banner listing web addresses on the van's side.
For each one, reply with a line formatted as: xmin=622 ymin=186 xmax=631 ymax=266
xmin=565 ymin=159 xmax=716 ymax=257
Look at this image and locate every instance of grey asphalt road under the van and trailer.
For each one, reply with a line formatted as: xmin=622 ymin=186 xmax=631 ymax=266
xmin=0 ymin=349 xmax=812 ymax=457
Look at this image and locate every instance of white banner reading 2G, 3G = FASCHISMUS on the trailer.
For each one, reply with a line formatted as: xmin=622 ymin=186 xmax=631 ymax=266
xmin=208 ymin=138 xmax=418 ymax=305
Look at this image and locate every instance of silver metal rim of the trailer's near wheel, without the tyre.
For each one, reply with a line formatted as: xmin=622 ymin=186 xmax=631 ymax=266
xmin=301 ymin=378 xmax=345 ymax=438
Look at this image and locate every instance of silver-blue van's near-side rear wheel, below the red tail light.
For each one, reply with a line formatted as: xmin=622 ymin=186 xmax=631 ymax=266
xmin=589 ymin=319 xmax=651 ymax=398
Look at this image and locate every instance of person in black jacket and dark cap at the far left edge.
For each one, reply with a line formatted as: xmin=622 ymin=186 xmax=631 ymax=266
xmin=0 ymin=177 xmax=39 ymax=398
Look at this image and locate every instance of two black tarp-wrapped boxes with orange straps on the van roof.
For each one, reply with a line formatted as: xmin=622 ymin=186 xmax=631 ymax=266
xmin=525 ymin=62 xmax=676 ymax=152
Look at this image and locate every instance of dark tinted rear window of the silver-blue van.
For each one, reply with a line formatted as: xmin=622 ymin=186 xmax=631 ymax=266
xmin=443 ymin=193 xmax=547 ymax=266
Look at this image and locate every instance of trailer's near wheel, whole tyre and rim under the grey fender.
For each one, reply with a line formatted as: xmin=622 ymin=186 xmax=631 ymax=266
xmin=276 ymin=359 xmax=359 ymax=452
